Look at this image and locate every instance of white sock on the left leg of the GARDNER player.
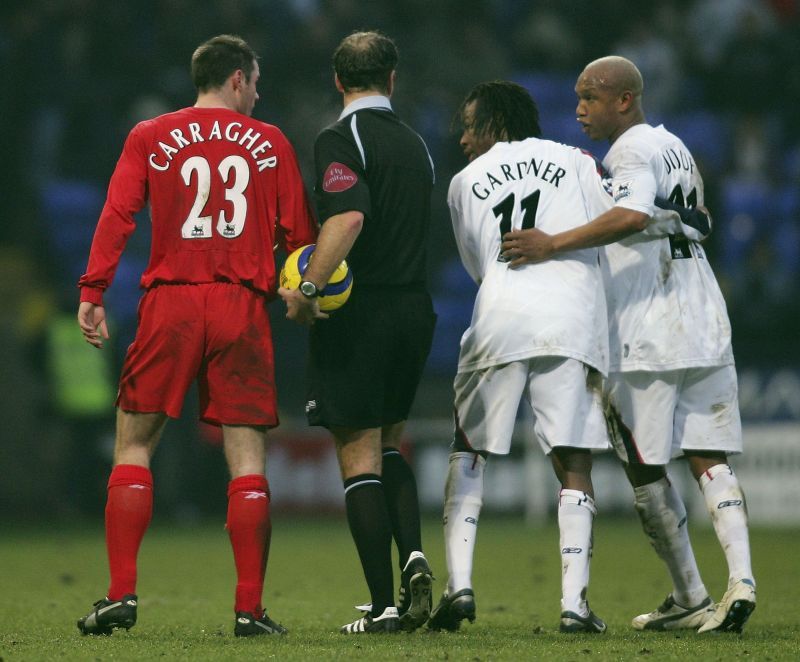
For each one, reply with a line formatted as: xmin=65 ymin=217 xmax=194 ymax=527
xmin=444 ymin=452 xmax=486 ymax=594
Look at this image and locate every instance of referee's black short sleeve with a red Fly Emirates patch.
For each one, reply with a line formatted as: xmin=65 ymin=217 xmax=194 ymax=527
xmin=314 ymin=124 xmax=372 ymax=223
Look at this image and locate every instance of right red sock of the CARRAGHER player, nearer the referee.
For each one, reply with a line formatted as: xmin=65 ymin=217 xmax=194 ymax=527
xmin=225 ymin=474 xmax=272 ymax=617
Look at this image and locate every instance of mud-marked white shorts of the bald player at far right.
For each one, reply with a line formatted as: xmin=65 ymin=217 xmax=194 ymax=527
xmin=606 ymin=365 xmax=742 ymax=465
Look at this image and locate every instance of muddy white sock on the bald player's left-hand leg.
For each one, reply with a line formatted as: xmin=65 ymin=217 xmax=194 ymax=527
xmin=633 ymin=477 xmax=708 ymax=607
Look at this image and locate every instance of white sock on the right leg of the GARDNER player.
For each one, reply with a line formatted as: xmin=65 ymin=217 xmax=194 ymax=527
xmin=558 ymin=489 xmax=597 ymax=617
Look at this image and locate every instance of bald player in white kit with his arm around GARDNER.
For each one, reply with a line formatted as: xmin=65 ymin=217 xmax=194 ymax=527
xmin=503 ymin=56 xmax=756 ymax=632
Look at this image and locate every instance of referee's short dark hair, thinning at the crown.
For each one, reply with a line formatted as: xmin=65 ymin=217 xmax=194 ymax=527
xmin=333 ymin=30 xmax=399 ymax=92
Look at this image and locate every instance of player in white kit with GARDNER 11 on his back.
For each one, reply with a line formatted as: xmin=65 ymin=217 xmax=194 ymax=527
xmin=428 ymin=81 xmax=611 ymax=632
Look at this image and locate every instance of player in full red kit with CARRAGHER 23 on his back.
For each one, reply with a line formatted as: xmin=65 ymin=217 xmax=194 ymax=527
xmin=78 ymin=35 xmax=317 ymax=636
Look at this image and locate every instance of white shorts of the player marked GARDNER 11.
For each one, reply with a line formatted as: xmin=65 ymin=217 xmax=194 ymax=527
xmin=454 ymin=356 xmax=609 ymax=455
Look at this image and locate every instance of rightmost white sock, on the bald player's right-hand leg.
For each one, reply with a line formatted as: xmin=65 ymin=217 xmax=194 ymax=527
xmin=699 ymin=464 xmax=753 ymax=587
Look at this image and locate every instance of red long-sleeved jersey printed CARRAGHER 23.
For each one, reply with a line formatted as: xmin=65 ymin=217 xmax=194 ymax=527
xmin=78 ymin=108 xmax=318 ymax=305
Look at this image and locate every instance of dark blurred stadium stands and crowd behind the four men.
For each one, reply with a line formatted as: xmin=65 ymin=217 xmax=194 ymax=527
xmin=0 ymin=0 xmax=800 ymax=517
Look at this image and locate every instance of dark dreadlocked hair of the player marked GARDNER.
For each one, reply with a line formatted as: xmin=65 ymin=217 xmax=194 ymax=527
xmin=453 ymin=80 xmax=542 ymax=140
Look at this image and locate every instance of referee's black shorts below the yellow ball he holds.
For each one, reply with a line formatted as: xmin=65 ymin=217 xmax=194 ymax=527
xmin=306 ymin=287 xmax=436 ymax=430
